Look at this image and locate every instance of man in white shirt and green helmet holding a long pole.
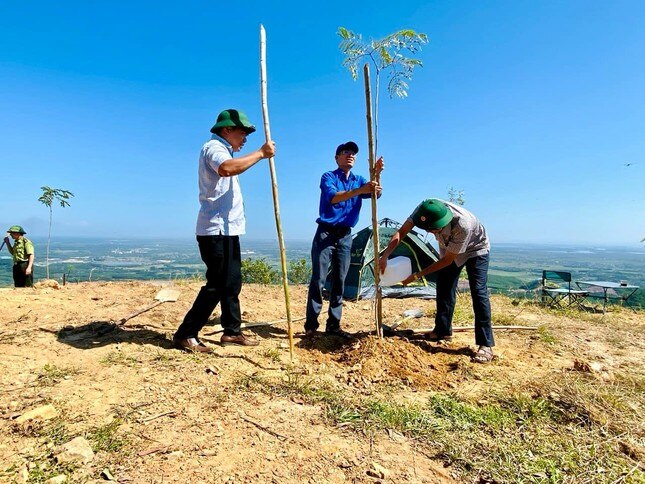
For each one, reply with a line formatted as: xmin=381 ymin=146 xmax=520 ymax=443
xmin=173 ymin=109 xmax=275 ymax=353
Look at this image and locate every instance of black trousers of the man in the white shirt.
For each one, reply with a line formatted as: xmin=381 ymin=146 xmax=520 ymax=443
xmin=175 ymin=235 xmax=242 ymax=339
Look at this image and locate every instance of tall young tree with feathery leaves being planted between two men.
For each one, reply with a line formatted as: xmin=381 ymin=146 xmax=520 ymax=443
xmin=338 ymin=27 xmax=428 ymax=336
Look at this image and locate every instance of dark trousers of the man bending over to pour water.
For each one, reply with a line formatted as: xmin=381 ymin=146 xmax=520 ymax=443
xmin=434 ymin=254 xmax=495 ymax=346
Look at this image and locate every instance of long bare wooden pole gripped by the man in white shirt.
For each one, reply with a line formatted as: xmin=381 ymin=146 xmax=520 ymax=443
xmin=260 ymin=24 xmax=293 ymax=361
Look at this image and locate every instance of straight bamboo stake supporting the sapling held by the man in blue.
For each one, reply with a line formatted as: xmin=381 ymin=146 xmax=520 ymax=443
xmin=363 ymin=64 xmax=383 ymax=338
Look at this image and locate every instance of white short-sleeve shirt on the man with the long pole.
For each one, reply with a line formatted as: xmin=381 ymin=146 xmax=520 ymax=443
xmin=195 ymin=134 xmax=246 ymax=235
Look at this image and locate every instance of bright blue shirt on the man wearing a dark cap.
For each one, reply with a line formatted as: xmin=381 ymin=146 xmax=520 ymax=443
xmin=316 ymin=168 xmax=371 ymax=228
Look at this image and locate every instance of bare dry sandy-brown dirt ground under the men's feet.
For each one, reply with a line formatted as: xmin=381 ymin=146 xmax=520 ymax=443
xmin=0 ymin=282 xmax=645 ymax=483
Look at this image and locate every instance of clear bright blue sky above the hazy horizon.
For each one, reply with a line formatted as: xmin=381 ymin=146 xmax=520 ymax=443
xmin=0 ymin=0 xmax=645 ymax=246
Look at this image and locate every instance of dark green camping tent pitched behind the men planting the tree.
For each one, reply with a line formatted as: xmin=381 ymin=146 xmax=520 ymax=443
xmin=325 ymin=218 xmax=439 ymax=300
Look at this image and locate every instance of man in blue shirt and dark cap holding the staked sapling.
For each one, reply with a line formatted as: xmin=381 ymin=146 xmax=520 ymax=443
xmin=305 ymin=141 xmax=383 ymax=339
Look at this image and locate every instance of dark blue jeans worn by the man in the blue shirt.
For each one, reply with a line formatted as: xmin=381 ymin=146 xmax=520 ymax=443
xmin=305 ymin=225 xmax=352 ymax=331
